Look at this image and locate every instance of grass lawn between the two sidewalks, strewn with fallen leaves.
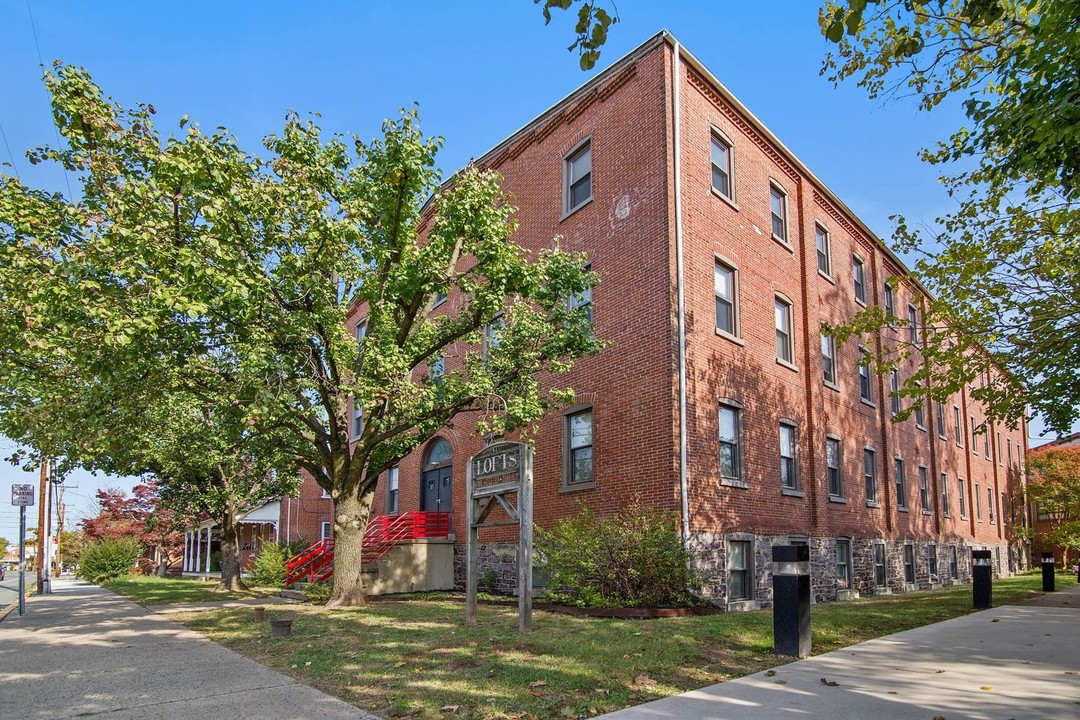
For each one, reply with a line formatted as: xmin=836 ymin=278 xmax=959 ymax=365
xmin=154 ymin=574 xmax=1076 ymax=719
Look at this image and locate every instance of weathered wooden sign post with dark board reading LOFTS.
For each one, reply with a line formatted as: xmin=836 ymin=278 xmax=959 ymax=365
xmin=465 ymin=443 xmax=532 ymax=633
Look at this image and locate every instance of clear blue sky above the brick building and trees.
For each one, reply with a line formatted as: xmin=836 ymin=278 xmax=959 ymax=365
xmin=0 ymin=0 xmax=1062 ymax=539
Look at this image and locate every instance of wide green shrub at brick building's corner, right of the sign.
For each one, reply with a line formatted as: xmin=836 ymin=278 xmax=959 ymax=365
xmin=537 ymin=503 xmax=702 ymax=608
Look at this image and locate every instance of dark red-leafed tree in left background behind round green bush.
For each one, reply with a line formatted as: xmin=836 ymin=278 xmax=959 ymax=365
xmin=82 ymin=480 xmax=184 ymax=574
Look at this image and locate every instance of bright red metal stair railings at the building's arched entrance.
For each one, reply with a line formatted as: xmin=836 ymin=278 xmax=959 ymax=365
xmin=285 ymin=511 xmax=450 ymax=587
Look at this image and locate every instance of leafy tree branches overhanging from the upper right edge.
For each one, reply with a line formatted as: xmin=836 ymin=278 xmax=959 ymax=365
xmin=820 ymin=0 xmax=1080 ymax=432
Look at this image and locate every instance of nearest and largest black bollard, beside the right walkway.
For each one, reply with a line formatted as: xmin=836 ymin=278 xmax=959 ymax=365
xmin=772 ymin=545 xmax=810 ymax=657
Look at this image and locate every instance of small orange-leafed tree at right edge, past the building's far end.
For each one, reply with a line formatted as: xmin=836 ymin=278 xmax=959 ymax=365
xmin=1027 ymin=447 xmax=1080 ymax=568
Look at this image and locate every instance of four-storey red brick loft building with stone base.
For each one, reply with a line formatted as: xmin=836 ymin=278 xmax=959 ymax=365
xmin=252 ymin=32 xmax=1027 ymax=609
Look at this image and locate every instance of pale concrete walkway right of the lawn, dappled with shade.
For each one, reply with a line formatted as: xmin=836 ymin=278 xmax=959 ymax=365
xmin=602 ymin=586 xmax=1080 ymax=720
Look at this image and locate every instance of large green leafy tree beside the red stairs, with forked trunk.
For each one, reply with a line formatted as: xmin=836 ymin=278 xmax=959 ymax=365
xmin=0 ymin=66 xmax=602 ymax=606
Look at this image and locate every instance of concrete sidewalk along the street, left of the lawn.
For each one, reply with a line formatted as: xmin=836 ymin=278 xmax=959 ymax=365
xmin=0 ymin=581 xmax=377 ymax=720
